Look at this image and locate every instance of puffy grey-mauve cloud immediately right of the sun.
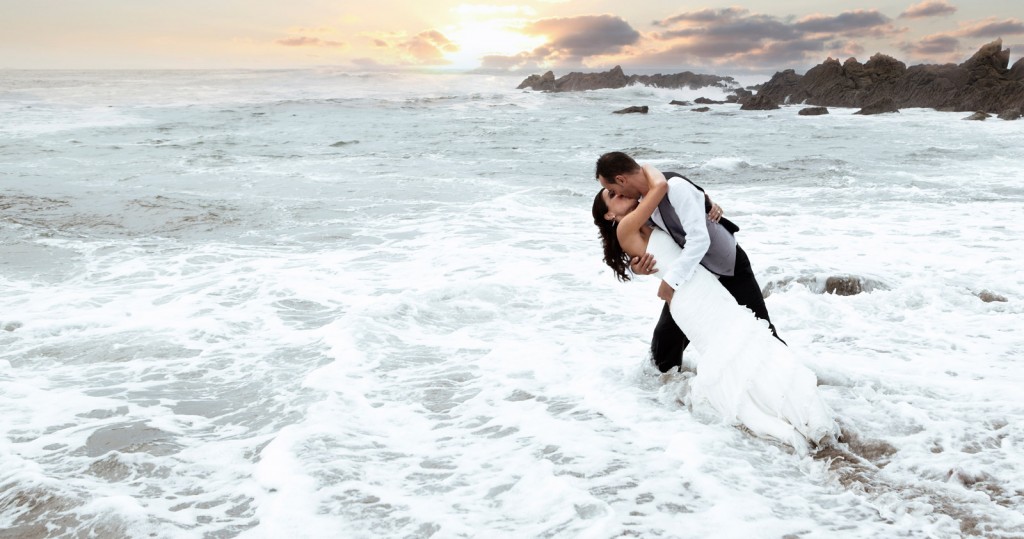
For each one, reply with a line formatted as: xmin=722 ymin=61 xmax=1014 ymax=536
xmin=521 ymin=15 xmax=640 ymax=58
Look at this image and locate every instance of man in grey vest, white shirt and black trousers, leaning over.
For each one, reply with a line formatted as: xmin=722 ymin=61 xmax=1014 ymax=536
xmin=595 ymin=152 xmax=785 ymax=372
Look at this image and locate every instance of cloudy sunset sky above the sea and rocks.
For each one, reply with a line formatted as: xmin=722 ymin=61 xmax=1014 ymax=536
xmin=0 ymin=0 xmax=1024 ymax=75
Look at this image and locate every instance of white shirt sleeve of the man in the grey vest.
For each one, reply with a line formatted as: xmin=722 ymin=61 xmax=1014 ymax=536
xmin=665 ymin=178 xmax=711 ymax=290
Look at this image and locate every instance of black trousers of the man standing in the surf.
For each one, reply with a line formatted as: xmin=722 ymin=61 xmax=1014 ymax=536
xmin=650 ymin=244 xmax=785 ymax=372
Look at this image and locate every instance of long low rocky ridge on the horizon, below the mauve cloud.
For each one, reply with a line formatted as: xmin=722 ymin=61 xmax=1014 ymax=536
xmin=517 ymin=66 xmax=737 ymax=92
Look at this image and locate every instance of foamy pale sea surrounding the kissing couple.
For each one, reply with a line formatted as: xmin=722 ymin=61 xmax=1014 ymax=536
xmin=0 ymin=69 xmax=1024 ymax=538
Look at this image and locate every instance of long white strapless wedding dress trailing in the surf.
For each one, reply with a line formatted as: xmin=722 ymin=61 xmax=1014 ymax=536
xmin=647 ymin=229 xmax=839 ymax=454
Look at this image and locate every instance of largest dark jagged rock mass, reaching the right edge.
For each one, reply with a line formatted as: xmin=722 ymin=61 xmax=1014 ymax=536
xmin=757 ymin=39 xmax=1024 ymax=114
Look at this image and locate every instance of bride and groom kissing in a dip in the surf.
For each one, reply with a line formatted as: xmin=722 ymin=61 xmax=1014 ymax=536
xmin=593 ymin=152 xmax=840 ymax=454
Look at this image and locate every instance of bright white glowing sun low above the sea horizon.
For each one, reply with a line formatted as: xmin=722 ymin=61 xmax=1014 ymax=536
xmin=444 ymin=19 xmax=545 ymax=69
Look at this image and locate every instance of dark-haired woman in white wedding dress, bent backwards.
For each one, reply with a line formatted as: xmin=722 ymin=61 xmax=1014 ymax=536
xmin=593 ymin=165 xmax=839 ymax=454
